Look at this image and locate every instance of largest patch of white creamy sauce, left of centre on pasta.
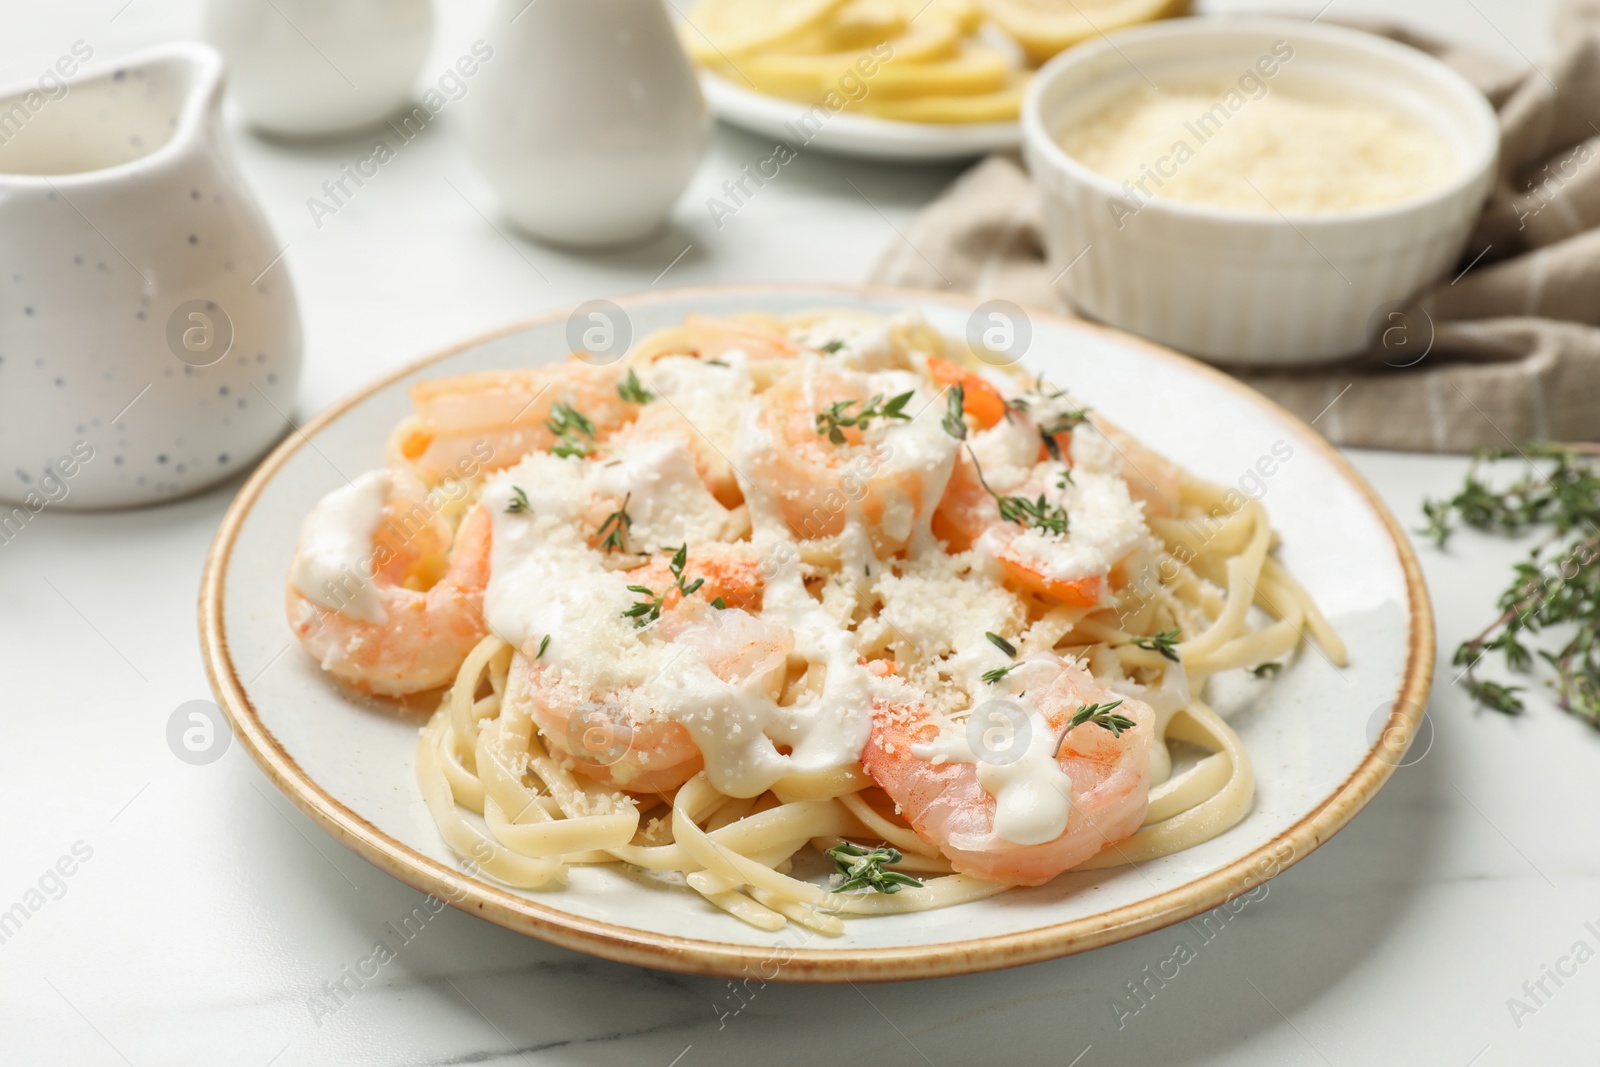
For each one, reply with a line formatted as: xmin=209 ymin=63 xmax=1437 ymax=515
xmin=483 ymin=415 xmax=889 ymax=797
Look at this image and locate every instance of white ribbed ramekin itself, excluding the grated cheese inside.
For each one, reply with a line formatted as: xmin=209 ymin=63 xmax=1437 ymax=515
xmin=1022 ymin=18 xmax=1499 ymax=366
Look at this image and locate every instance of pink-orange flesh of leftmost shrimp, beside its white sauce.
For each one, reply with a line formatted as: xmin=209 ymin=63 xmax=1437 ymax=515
xmin=286 ymin=475 xmax=493 ymax=696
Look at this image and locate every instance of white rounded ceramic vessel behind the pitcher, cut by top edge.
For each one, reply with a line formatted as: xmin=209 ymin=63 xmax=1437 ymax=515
xmin=205 ymin=0 xmax=434 ymax=136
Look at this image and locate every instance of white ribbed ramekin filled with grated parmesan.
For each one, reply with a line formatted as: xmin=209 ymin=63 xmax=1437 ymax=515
xmin=1022 ymin=18 xmax=1499 ymax=366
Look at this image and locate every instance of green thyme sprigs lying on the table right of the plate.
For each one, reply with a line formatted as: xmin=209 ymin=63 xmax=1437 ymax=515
xmin=1421 ymin=443 xmax=1600 ymax=726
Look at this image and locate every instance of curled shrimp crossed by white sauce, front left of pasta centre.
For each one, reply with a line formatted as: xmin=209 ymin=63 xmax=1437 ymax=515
xmin=530 ymin=600 xmax=794 ymax=793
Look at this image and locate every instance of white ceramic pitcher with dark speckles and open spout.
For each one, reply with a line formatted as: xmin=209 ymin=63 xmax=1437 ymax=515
xmin=0 ymin=43 xmax=301 ymax=518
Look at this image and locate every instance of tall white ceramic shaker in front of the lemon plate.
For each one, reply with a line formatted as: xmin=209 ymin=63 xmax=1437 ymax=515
xmin=462 ymin=0 xmax=710 ymax=248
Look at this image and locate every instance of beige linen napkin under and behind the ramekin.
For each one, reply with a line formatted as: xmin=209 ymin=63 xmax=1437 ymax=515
xmin=874 ymin=0 xmax=1600 ymax=451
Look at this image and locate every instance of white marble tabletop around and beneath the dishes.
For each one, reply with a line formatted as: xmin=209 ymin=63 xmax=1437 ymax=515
xmin=0 ymin=0 xmax=1600 ymax=1067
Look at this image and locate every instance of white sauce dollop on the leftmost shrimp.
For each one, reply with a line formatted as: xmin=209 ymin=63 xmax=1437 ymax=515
xmin=290 ymin=470 xmax=392 ymax=622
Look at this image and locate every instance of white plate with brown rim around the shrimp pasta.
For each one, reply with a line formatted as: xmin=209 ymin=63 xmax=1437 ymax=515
xmin=200 ymin=286 xmax=1434 ymax=981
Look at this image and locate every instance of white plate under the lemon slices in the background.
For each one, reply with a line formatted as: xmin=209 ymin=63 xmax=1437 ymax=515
xmin=701 ymin=72 xmax=1022 ymax=162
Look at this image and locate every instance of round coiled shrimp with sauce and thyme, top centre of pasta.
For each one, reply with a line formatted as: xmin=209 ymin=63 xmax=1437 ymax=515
xmin=741 ymin=362 xmax=955 ymax=557
